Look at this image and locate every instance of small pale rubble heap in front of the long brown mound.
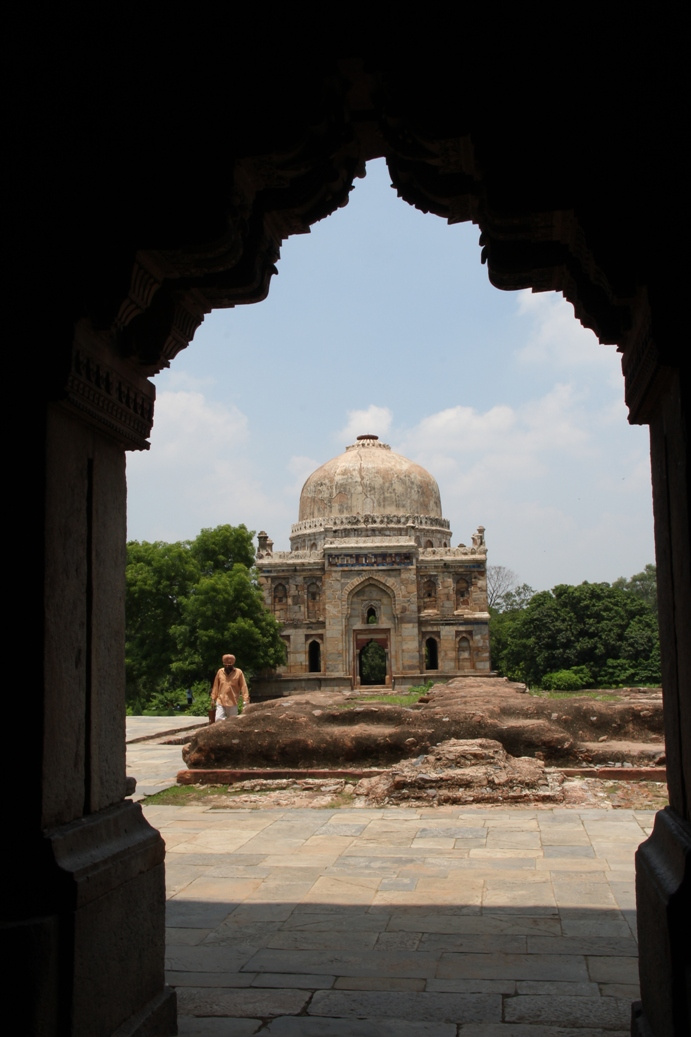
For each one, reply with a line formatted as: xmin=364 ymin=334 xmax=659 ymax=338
xmin=355 ymin=738 xmax=563 ymax=806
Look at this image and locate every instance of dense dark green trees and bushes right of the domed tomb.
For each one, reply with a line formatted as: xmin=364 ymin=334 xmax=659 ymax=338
xmin=490 ymin=565 xmax=660 ymax=691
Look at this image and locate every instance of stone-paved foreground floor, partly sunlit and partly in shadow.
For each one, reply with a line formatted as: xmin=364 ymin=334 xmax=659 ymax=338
xmin=144 ymin=806 xmax=654 ymax=1037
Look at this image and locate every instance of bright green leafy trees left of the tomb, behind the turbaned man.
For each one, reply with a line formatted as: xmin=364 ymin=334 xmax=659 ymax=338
xmin=126 ymin=526 xmax=285 ymax=709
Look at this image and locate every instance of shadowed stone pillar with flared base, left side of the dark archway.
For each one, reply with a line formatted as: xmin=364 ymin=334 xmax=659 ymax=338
xmin=3 ymin=333 xmax=175 ymax=1037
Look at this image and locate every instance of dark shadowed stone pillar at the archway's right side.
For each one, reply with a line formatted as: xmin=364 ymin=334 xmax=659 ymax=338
xmin=625 ymin=344 xmax=691 ymax=1037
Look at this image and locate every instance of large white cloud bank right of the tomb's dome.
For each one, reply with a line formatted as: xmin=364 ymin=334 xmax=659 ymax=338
xmin=394 ymin=382 xmax=649 ymax=588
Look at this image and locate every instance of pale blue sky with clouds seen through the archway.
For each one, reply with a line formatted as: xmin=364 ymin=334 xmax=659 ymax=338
xmin=128 ymin=155 xmax=654 ymax=589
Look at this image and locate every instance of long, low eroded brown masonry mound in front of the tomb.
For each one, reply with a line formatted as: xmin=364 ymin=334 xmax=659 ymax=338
xmin=178 ymin=677 xmax=664 ymax=769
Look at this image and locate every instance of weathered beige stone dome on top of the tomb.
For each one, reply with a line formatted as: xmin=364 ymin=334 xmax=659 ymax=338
xmin=299 ymin=436 xmax=442 ymax=523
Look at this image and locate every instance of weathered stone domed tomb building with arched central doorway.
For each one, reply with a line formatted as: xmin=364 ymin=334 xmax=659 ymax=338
xmin=253 ymin=436 xmax=490 ymax=697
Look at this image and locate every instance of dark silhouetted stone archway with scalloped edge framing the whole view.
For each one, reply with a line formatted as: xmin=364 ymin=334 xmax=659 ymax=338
xmin=18 ymin=40 xmax=691 ymax=1037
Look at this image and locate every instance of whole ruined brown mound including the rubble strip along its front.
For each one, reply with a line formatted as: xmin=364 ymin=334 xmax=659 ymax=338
xmin=162 ymin=678 xmax=667 ymax=810
